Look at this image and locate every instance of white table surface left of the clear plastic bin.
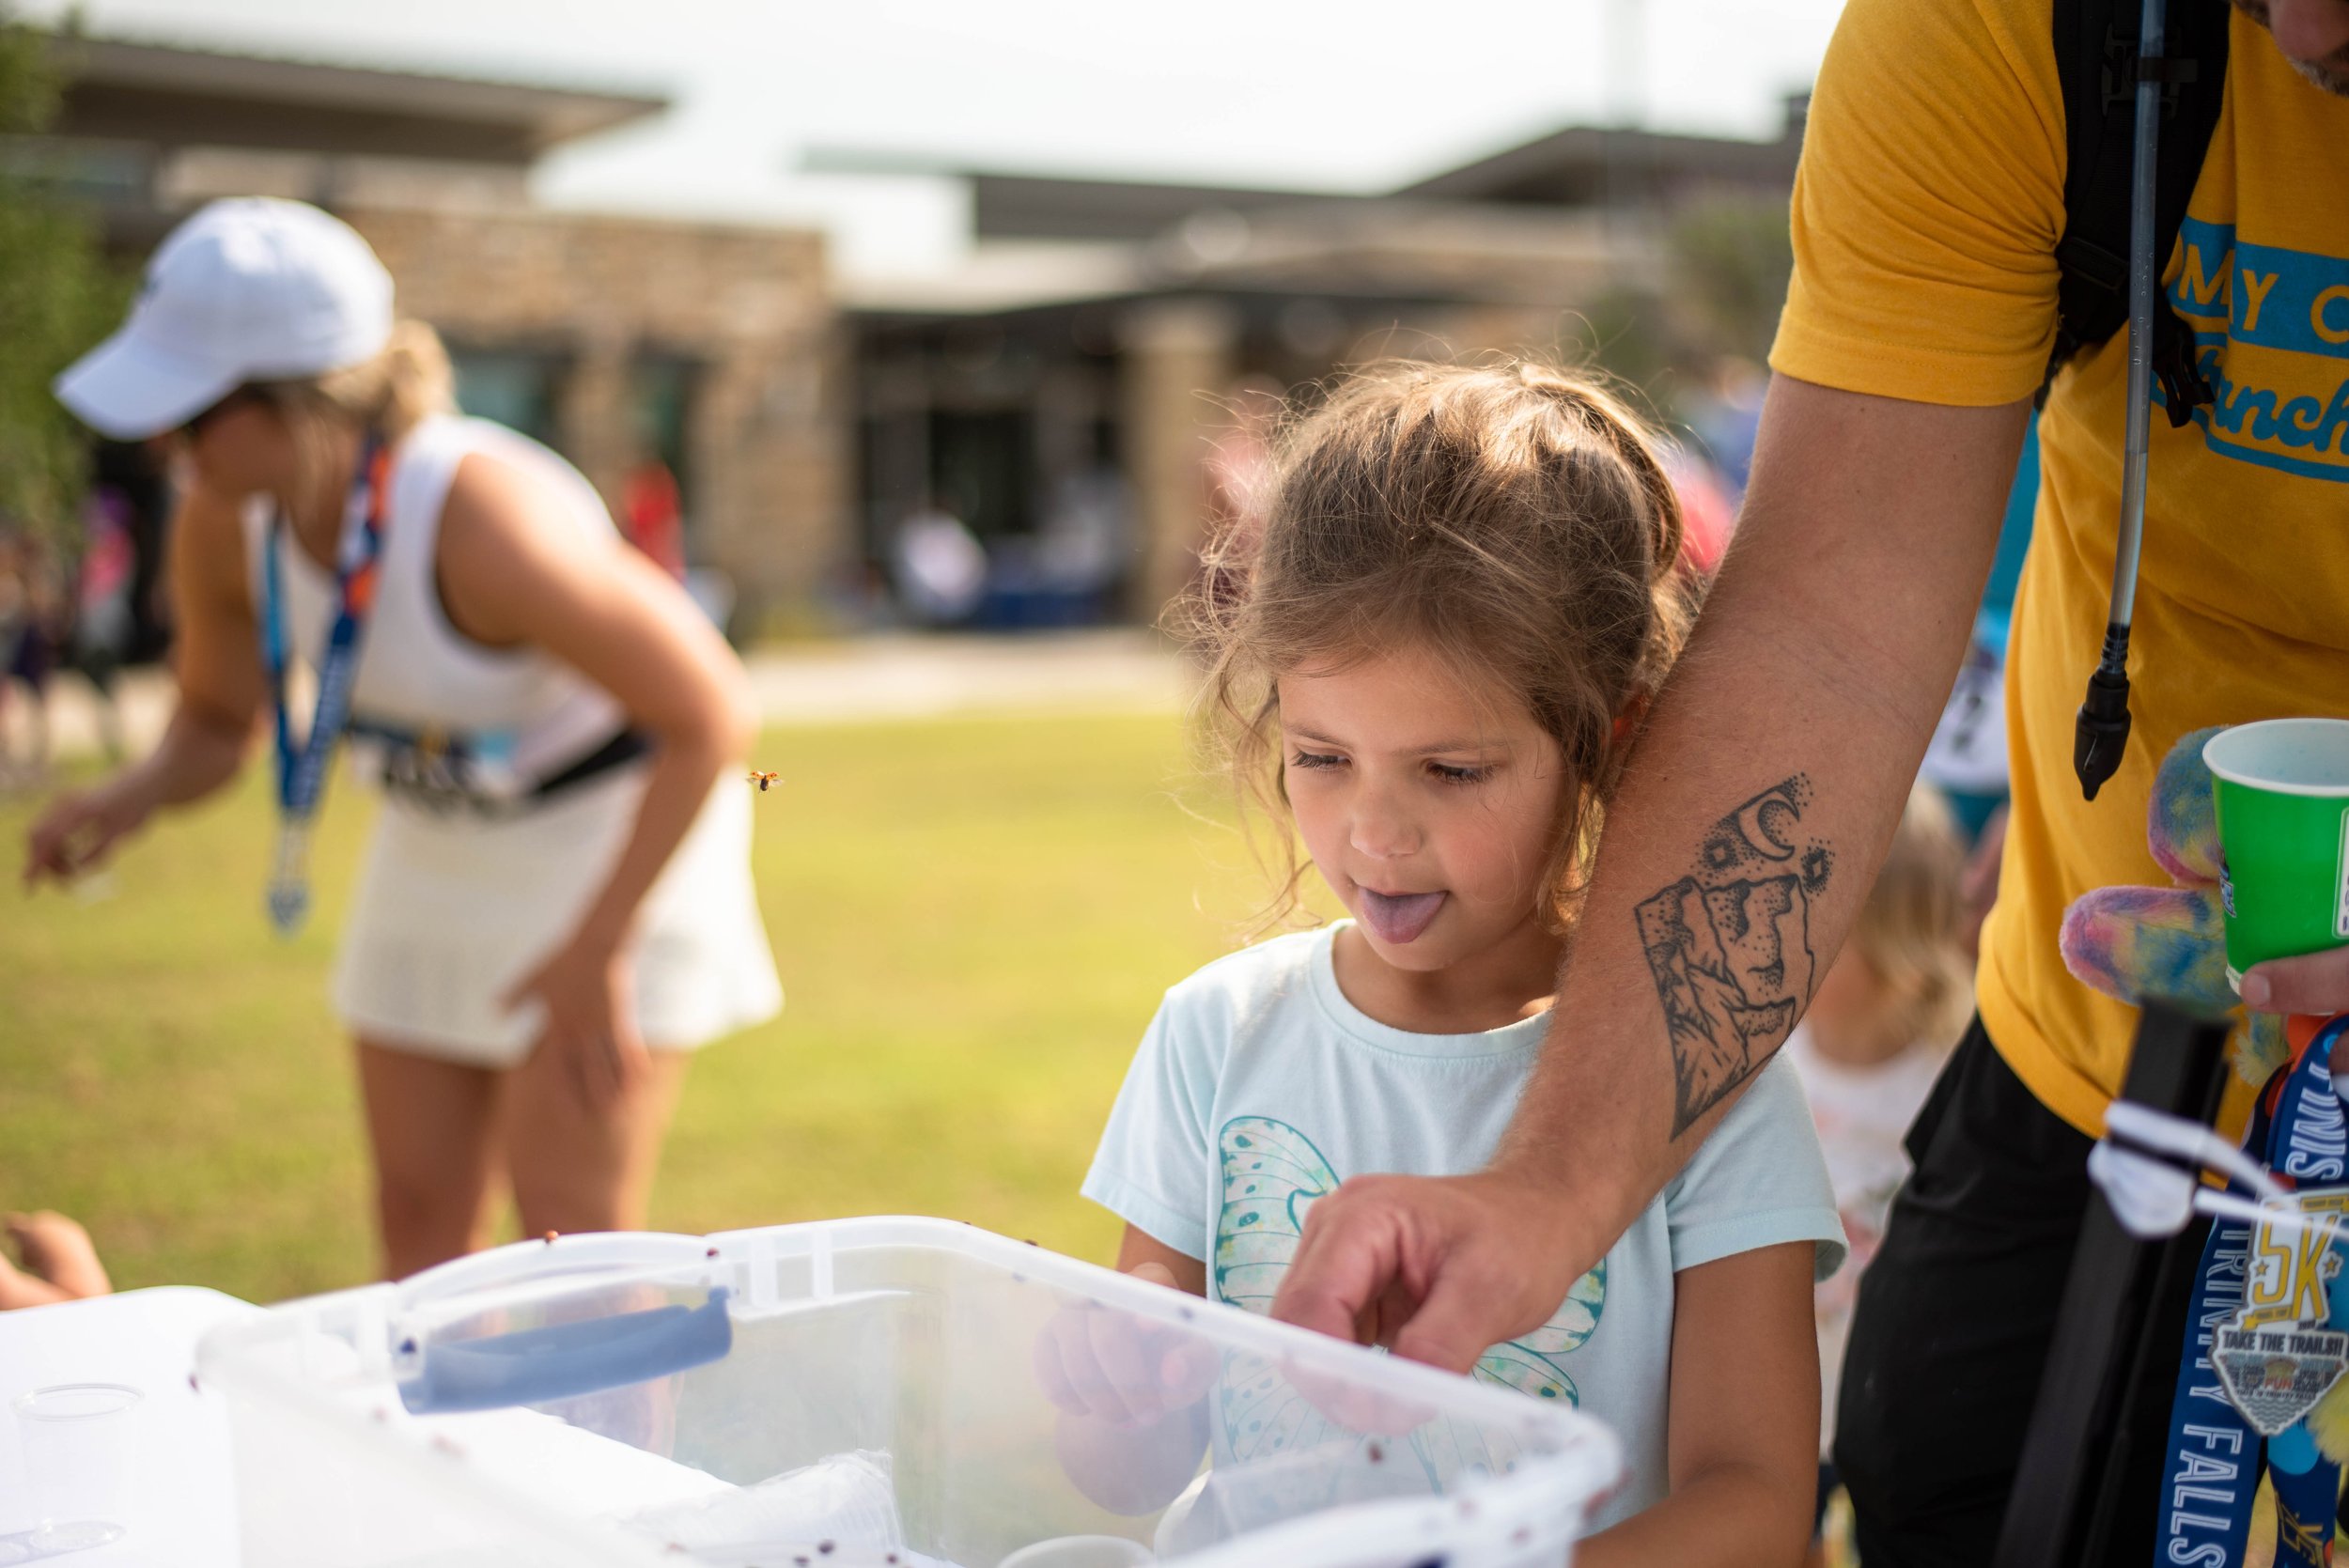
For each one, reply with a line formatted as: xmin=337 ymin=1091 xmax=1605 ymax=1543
xmin=0 ymin=1286 xmax=261 ymax=1568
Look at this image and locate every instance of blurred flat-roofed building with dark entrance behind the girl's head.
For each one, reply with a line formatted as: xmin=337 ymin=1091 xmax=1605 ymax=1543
xmin=811 ymin=99 xmax=1804 ymax=622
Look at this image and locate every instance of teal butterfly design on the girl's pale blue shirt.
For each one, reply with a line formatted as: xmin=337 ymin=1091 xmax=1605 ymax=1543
xmin=1212 ymin=1117 xmax=1607 ymax=1486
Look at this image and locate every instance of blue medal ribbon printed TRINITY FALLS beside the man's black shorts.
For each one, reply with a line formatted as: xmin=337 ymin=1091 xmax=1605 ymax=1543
xmin=2155 ymin=1018 xmax=2349 ymax=1568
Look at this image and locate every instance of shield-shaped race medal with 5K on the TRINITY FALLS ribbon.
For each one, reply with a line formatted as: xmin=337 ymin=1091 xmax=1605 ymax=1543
xmin=2211 ymin=1188 xmax=2349 ymax=1436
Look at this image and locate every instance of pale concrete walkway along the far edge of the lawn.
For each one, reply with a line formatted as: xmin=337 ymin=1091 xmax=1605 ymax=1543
xmin=0 ymin=629 xmax=1193 ymax=784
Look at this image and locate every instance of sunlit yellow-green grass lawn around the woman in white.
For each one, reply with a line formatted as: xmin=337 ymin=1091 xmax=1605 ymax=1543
xmin=0 ymin=719 xmax=1306 ymax=1300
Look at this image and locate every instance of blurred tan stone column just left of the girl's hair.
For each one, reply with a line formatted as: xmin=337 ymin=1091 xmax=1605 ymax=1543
xmin=1118 ymin=298 xmax=1240 ymax=625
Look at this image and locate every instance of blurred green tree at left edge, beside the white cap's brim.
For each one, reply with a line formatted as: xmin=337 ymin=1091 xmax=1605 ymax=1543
xmin=0 ymin=0 xmax=130 ymax=537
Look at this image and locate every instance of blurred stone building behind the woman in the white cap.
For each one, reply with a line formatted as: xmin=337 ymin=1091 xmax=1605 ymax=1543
xmin=29 ymin=39 xmax=855 ymax=611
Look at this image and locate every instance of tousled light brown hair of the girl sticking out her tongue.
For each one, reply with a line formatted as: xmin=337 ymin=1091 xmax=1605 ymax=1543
xmin=1170 ymin=362 xmax=1696 ymax=934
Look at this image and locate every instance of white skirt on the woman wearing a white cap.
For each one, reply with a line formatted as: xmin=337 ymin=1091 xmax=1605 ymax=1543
xmin=334 ymin=768 xmax=783 ymax=1068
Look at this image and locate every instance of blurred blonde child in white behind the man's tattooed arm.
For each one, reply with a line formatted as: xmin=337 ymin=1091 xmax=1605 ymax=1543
xmin=1783 ymin=784 xmax=1973 ymax=1516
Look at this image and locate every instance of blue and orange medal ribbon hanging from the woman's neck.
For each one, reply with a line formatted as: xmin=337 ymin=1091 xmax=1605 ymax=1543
xmin=261 ymin=434 xmax=390 ymax=934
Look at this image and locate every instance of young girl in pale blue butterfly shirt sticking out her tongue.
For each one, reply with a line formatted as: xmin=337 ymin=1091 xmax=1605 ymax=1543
xmin=1041 ymin=364 xmax=1842 ymax=1568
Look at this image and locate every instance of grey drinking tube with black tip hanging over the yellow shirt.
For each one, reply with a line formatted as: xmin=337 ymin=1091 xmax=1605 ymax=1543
xmin=2072 ymin=0 xmax=2169 ymax=800
